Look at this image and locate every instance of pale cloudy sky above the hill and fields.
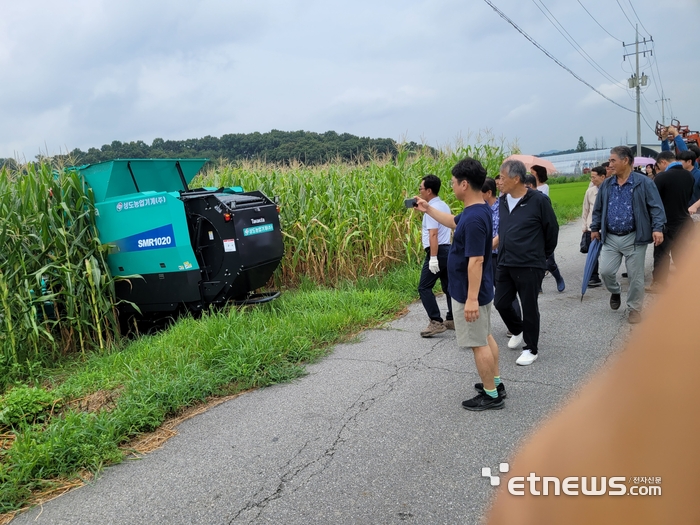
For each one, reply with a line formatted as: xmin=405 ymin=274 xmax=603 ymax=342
xmin=0 ymin=0 xmax=700 ymax=160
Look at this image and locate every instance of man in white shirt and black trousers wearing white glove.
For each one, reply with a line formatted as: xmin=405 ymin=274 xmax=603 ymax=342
xmin=418 ymin=175 xmax=455 ymax=337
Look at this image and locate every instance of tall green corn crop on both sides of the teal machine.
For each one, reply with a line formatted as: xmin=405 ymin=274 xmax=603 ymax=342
xmin=0 ymin=136 xmax=509 ymax=380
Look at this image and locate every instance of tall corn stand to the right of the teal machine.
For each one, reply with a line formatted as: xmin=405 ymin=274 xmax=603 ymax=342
xmin=193 ymin=137 xmax=507 ymax=286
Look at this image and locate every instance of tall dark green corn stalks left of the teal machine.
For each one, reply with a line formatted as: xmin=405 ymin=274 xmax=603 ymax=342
xmin=0 ymin=163 xmax=118 ymax=391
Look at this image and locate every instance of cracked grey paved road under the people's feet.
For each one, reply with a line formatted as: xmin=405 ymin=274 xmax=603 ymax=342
xmin=13 ymin=225 xmax=651 ymax=525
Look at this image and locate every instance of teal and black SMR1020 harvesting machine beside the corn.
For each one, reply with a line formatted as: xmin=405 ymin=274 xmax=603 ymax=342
xmin=76 ymin=159 xmax=284 ymax=315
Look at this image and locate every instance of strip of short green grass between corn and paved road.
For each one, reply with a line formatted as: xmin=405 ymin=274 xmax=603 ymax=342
xmin=0 ymin=265 xmax=420 ymax=512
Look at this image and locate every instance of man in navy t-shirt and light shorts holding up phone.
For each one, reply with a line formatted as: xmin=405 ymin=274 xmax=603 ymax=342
xmin=417 ymin=158 xmax=506 ymax=411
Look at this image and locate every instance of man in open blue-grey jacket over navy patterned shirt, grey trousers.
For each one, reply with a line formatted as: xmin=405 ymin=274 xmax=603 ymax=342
xmin=591 ymin=146 xmax=666 ymax=324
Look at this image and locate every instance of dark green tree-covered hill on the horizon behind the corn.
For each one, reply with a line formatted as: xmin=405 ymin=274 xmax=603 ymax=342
xmin=0 ymin=129 xmax=434 ymax=166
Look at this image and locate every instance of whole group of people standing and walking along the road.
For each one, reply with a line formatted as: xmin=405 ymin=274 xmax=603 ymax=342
xmin=415 ymin=128 xmax=700 ymax=411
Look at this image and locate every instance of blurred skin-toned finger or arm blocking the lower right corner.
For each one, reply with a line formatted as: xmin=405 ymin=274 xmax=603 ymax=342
xmin=488 ymin=229 xmax=700 ymax=525
